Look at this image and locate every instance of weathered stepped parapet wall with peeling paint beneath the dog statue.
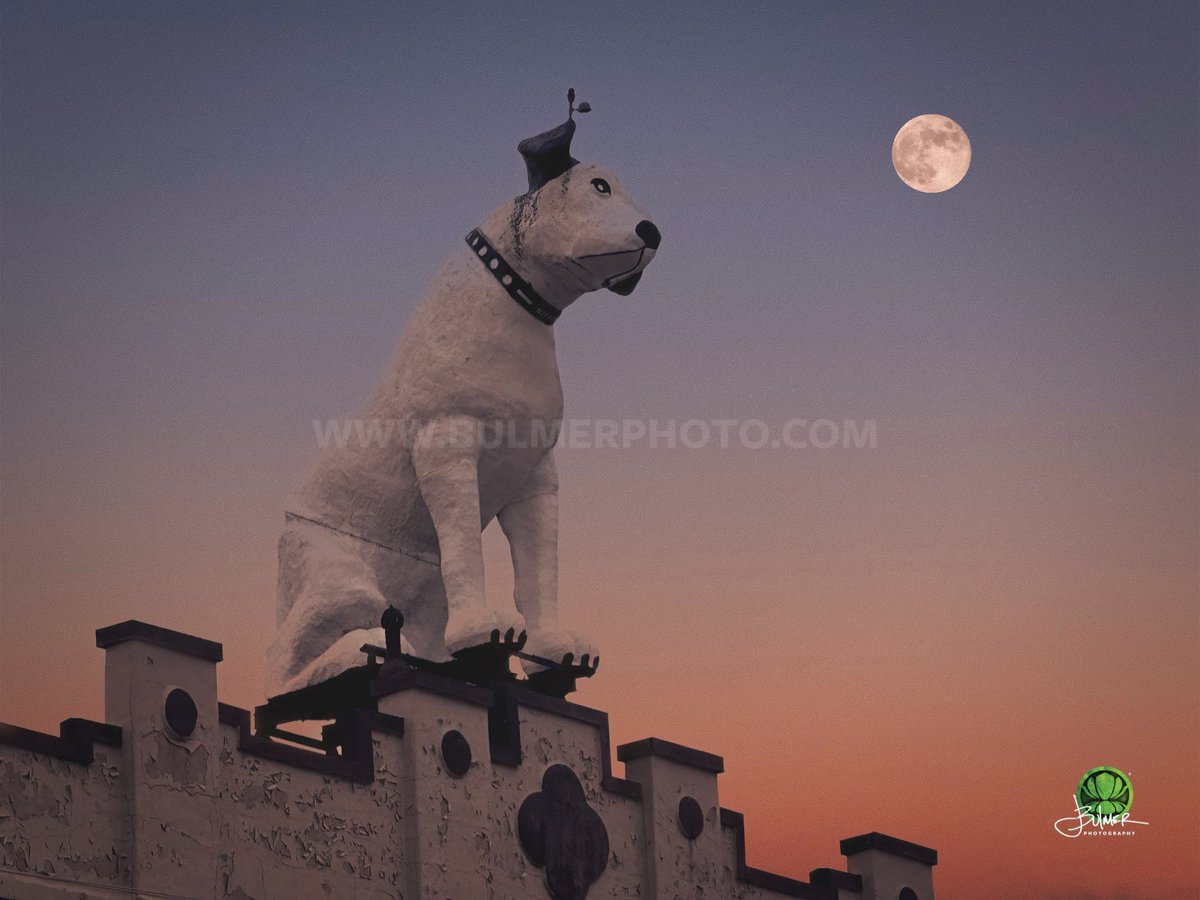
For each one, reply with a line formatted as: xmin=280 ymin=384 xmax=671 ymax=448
xmin=0 ymin=623 xmax=936 ymax=900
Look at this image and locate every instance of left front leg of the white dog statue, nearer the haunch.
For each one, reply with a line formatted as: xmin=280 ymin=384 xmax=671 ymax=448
xmin=413 ymin=416 xmax=524 ymax=653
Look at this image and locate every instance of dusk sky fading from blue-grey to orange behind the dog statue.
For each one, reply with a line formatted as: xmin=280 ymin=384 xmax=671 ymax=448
xmin=0 ymin=0 xmax=1200 ymax=900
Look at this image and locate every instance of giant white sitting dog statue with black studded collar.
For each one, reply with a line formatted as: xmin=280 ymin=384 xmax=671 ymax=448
xmin=268 ymin=97 xmax=660 ymax=691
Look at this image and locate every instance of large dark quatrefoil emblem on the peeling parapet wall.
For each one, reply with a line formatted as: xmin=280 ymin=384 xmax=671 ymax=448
xmin=517 ymin=766 xmax=608 ymax=900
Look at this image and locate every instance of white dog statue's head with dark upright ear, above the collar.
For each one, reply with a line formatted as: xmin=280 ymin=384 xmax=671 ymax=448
xmin=472 ymin=91 xmax=662 ymax=310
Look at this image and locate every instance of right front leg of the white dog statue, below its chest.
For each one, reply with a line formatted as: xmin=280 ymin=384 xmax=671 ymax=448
xmin=498 ymin=452 xmax=595 ymax=668
